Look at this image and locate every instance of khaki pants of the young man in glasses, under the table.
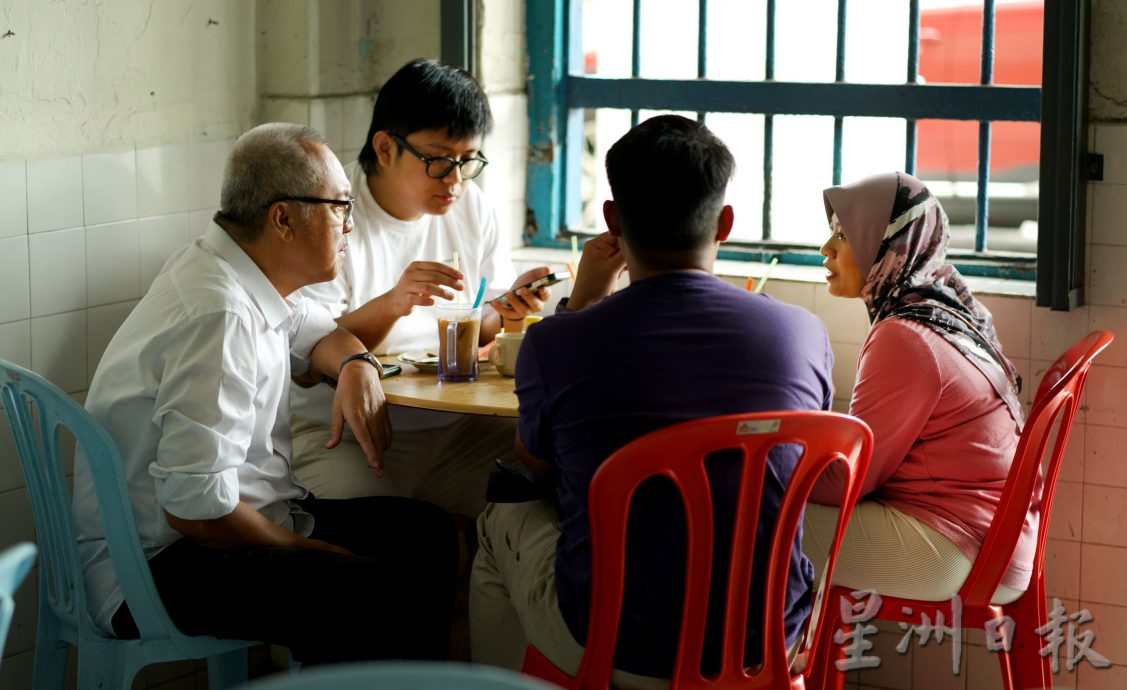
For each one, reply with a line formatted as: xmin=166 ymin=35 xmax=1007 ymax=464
xmin=293 ymin=415 xmax=516 ymax=516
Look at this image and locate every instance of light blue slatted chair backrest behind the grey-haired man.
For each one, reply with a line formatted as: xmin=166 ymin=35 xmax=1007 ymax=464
xmin=0 ymin=360 xmax=183 ymax=640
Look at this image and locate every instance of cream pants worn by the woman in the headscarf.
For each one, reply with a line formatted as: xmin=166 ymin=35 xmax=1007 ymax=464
xmin=802 ymin=501 xmax=1021 ymax=605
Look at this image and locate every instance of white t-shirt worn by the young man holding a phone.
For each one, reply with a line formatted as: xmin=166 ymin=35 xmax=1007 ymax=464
xmin=291 ymin=162 xmax=516 ymax=431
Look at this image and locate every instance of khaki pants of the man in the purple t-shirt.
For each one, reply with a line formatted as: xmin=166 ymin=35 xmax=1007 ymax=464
xmin=470 ymin=501 xmax=669 ymax=690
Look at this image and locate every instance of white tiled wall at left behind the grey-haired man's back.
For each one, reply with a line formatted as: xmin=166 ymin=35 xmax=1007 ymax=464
xmin=0 ymin=140 xmax=231 ymax=392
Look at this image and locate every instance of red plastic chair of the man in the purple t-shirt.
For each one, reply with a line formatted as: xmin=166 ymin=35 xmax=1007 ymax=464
xmin=524 ymin=412 xmax=872 ymax=690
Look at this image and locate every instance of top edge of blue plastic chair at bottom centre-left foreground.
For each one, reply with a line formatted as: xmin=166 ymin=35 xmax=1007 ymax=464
xmin=247 ymin=661 xmax=559 ymax=690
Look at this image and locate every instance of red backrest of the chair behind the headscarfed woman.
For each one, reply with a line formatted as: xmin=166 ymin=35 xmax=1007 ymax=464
xmin=959 ymin=330 xmax=1115 ymax=607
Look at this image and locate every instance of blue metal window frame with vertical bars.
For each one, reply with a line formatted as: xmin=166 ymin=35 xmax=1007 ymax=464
xmin=525 ymin=0 xmax=1089 ymax=302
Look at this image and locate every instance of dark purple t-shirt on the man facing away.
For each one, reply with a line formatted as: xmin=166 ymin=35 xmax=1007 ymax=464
xmin=516 ymin=272 xmax=833 ymax=676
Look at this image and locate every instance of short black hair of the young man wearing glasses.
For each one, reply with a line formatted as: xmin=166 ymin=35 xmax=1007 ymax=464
xmin=358 ymin=58 xmax=492 ymax=175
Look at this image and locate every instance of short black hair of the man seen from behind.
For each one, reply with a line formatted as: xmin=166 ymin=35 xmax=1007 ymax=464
xmin=606 ymin=115 xmax=736 ymax=253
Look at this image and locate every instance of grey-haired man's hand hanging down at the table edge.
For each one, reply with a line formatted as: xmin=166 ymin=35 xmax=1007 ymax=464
xmin=325 ymin=360 xmax=391 ymax=477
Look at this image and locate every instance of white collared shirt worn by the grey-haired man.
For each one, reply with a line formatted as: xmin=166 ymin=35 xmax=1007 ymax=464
xmin=74 ymin=223 xmax=336 ymax=631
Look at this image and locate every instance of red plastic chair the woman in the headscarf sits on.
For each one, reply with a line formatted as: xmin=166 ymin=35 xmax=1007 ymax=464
xmin=807 ymin=330 xmax=1115 ymax=690
